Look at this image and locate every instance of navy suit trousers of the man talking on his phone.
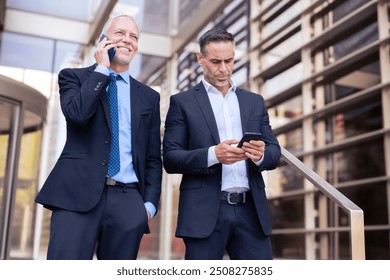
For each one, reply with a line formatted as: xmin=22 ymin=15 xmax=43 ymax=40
xmin=47 ymin=186 xmax=148 ymax=260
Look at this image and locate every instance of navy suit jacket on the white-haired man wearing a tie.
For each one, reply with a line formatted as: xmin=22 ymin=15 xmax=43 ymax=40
xmin=36 ymin=64 xmax=162 ymax=211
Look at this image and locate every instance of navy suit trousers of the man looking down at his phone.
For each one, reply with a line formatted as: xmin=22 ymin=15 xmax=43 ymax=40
xmin=183 ymin=195 xmax=272 ymax=260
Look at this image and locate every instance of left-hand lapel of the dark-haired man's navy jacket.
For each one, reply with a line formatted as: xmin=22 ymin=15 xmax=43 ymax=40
xmin=193 ymin=82 xmax=220 ymax=144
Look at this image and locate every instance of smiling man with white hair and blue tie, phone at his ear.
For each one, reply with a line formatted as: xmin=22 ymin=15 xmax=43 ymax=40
xmin=36 ymin=15 xmax=162 ymax=259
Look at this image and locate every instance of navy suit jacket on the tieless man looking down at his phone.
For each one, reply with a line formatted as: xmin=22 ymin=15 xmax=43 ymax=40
xmin=163 ymin=83 xmax=280 ymax=238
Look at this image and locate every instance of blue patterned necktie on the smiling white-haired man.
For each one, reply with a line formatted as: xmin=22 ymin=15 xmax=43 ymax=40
xmin=107 ymin=73 xmax=120 ymax=177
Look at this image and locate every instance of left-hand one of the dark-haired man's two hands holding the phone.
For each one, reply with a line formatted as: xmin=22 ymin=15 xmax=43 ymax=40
xmin=215 ymin=140 xmax=247 ymax=164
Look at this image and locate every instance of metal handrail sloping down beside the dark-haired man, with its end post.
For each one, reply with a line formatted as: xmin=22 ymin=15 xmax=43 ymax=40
xmin=281 ymin=147 xmax=366 ymax=260
